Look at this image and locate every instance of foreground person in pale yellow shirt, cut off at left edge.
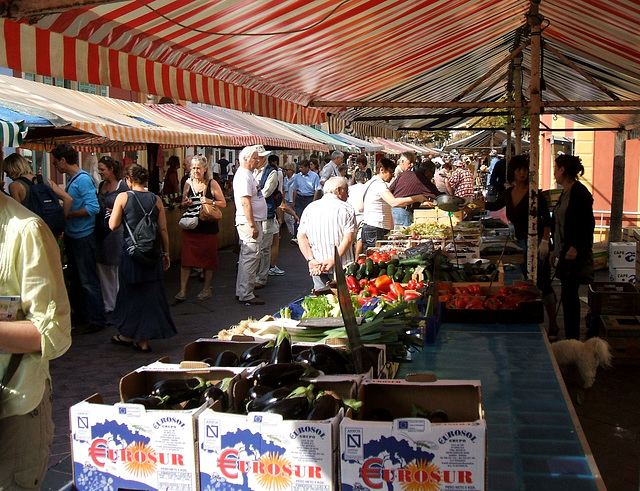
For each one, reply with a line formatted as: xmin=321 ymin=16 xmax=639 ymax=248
xmin=0 ymin=193 xmax=71 ymax=490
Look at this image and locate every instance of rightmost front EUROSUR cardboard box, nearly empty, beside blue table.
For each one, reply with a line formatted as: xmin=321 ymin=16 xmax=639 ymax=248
xmin=340 ymin=380 xmax=487 ymax=491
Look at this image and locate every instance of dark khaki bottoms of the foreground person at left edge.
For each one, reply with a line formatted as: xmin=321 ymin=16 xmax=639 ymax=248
xmin=0 ymin=381 xmax=53 ymax=490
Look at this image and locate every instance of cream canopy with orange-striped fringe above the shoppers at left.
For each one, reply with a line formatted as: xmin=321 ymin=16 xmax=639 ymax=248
xmin=0 ymin=75 xmax=233 ymax=150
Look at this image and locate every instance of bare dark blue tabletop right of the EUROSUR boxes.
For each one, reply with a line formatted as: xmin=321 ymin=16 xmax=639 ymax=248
xmin=396 ymin=324 xmax=605 ymax=491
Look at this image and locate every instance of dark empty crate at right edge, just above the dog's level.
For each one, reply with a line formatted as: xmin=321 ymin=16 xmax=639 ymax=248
xmin=600 ymin=315 xmax=640 ymax=364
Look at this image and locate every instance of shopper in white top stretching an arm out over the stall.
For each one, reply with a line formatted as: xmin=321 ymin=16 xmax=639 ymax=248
xmin=360 ymin=158 xmax=428 ymax=252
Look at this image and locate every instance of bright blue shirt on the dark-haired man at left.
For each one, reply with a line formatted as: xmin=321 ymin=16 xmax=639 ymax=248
xmin=64 ymin=169 xmax=100 ymax=239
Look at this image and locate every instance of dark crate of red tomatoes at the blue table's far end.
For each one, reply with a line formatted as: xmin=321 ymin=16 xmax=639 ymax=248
xmin=438 ymin=282 xmax=544 ymax=324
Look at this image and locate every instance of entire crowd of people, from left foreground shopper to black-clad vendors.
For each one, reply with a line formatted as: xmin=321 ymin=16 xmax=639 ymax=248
xmin=0 ymin=140 xmax=594 ymax=488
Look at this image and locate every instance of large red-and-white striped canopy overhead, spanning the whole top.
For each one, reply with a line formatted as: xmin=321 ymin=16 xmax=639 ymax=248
xmin=0 ymin=0 xmax=640 ymax=134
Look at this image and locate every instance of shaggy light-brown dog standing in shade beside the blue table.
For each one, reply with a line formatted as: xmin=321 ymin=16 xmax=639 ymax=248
xmin=551 ymin=338 xmax=611 ymax=389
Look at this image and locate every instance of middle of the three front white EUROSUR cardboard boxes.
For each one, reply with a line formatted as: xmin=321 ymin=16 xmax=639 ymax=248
xmin=198 ymin=378 xmax=356 ymax=491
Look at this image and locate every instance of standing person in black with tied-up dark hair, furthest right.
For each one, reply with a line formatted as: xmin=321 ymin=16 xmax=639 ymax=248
xmin=553 ymin=154 xmax=595 ymax=339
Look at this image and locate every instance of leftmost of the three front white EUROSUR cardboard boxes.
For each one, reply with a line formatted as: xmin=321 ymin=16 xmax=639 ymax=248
xmin=69 ymin=394 xmax=210 ymax=491
